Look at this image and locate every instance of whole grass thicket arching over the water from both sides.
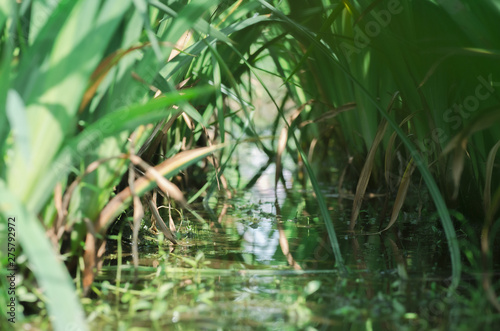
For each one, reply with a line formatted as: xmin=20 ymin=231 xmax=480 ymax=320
xmin=0 ymin=0 xmax=500 ymax=330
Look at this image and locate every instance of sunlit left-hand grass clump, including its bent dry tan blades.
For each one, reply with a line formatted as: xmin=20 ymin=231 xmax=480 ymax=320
xmin=0 ymin=0 xmax=282 ymax=330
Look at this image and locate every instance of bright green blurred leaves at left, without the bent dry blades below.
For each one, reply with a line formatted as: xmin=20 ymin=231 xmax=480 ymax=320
xmin=0 ymin=1 xmax=254 ymax=330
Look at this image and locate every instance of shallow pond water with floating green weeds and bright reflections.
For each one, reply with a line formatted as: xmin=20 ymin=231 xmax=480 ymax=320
xmin=91 ymin=172 xmax=500 ymax=330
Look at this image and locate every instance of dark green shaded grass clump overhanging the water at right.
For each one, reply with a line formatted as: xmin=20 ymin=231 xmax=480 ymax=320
xmin=254 ymin=1 xmax=500 ymax=296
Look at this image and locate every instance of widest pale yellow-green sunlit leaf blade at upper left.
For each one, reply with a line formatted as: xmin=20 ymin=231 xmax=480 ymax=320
xmin=7 ymin=0 xmax=130 ymax=201
